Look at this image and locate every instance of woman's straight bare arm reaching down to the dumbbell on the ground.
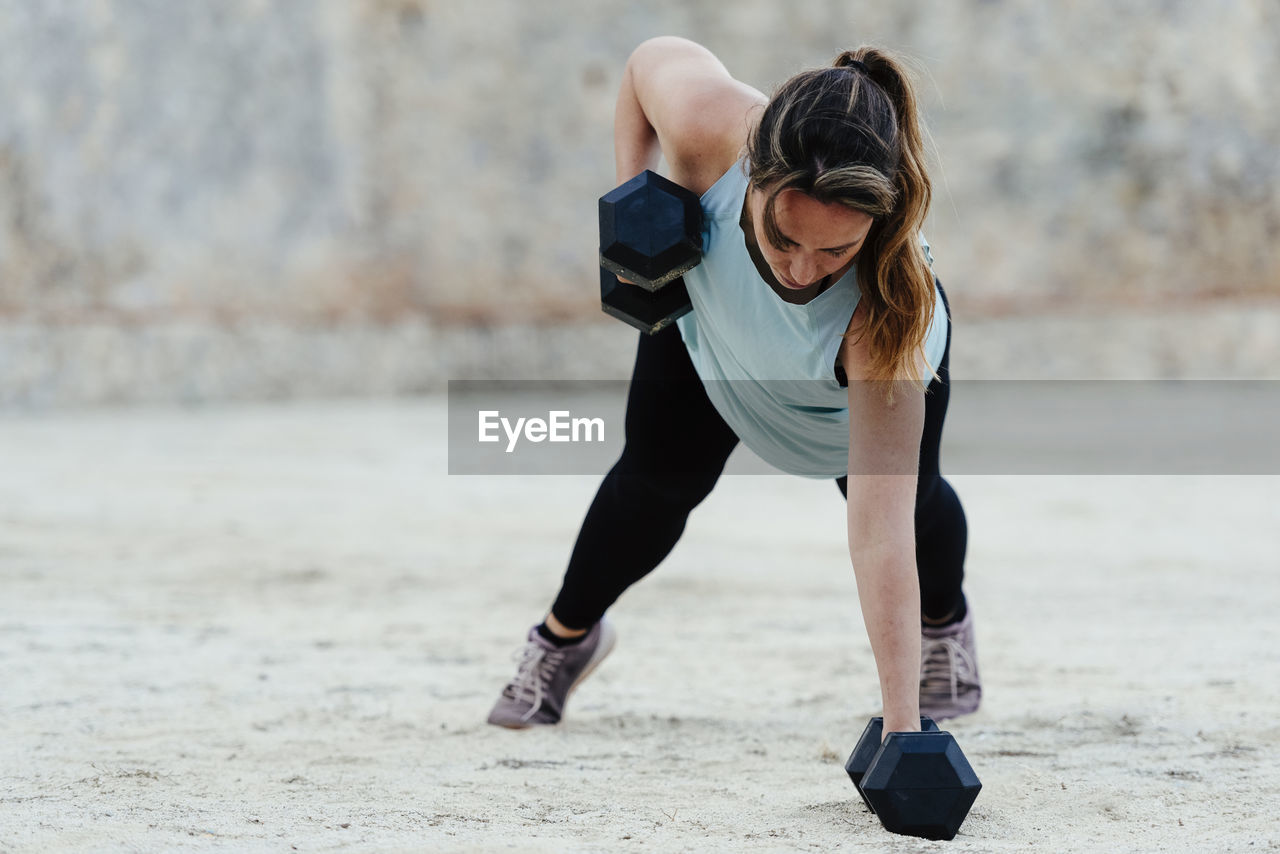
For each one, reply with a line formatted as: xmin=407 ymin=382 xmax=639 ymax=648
xmin=842 ymin=312 xmax=924 ymax=735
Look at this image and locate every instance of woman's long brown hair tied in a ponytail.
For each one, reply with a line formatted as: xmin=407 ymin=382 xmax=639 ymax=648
xmin=748 ymin=46 xmax=933 ymax=388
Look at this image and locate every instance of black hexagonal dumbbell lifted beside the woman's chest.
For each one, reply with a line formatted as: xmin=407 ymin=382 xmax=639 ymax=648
xmin=600 ymin=169 xmax=703 ymax=334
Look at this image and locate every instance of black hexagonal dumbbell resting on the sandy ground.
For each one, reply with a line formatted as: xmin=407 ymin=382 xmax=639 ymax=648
xmin=845 ymin=717 xmax=982 ymax=839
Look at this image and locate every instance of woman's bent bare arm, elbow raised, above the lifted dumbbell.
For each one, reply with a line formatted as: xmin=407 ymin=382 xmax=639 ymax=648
xmin=613 ymin=36 xmax=767 ymax=195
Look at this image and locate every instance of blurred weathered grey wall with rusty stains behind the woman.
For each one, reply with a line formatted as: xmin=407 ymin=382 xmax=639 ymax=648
xmin=0 ymin=0 xmax=1280 ymax=408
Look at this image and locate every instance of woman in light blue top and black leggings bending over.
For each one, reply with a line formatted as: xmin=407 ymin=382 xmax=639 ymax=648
xmin=489 ymin=37 xmax=980 ymax=734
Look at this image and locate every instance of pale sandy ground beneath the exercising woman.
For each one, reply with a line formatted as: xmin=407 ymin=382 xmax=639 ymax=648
xmin=0 ymin=398 xmax=1280 ymax=853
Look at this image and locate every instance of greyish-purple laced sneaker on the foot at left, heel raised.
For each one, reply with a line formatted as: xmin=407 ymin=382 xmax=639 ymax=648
xmin=489 ymin=620 xmax=618 ymax=730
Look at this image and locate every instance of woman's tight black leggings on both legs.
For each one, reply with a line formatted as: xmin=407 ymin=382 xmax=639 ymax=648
xmin=552 ymin=286 xmax=968 ymax=629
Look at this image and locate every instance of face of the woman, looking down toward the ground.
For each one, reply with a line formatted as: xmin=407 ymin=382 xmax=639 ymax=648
xmin=749 ymin=189 xmax=873 ymax=289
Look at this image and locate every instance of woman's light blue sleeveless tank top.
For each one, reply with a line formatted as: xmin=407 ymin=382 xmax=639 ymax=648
xmin=676 ymin=163 xmax=947 ymax=478
